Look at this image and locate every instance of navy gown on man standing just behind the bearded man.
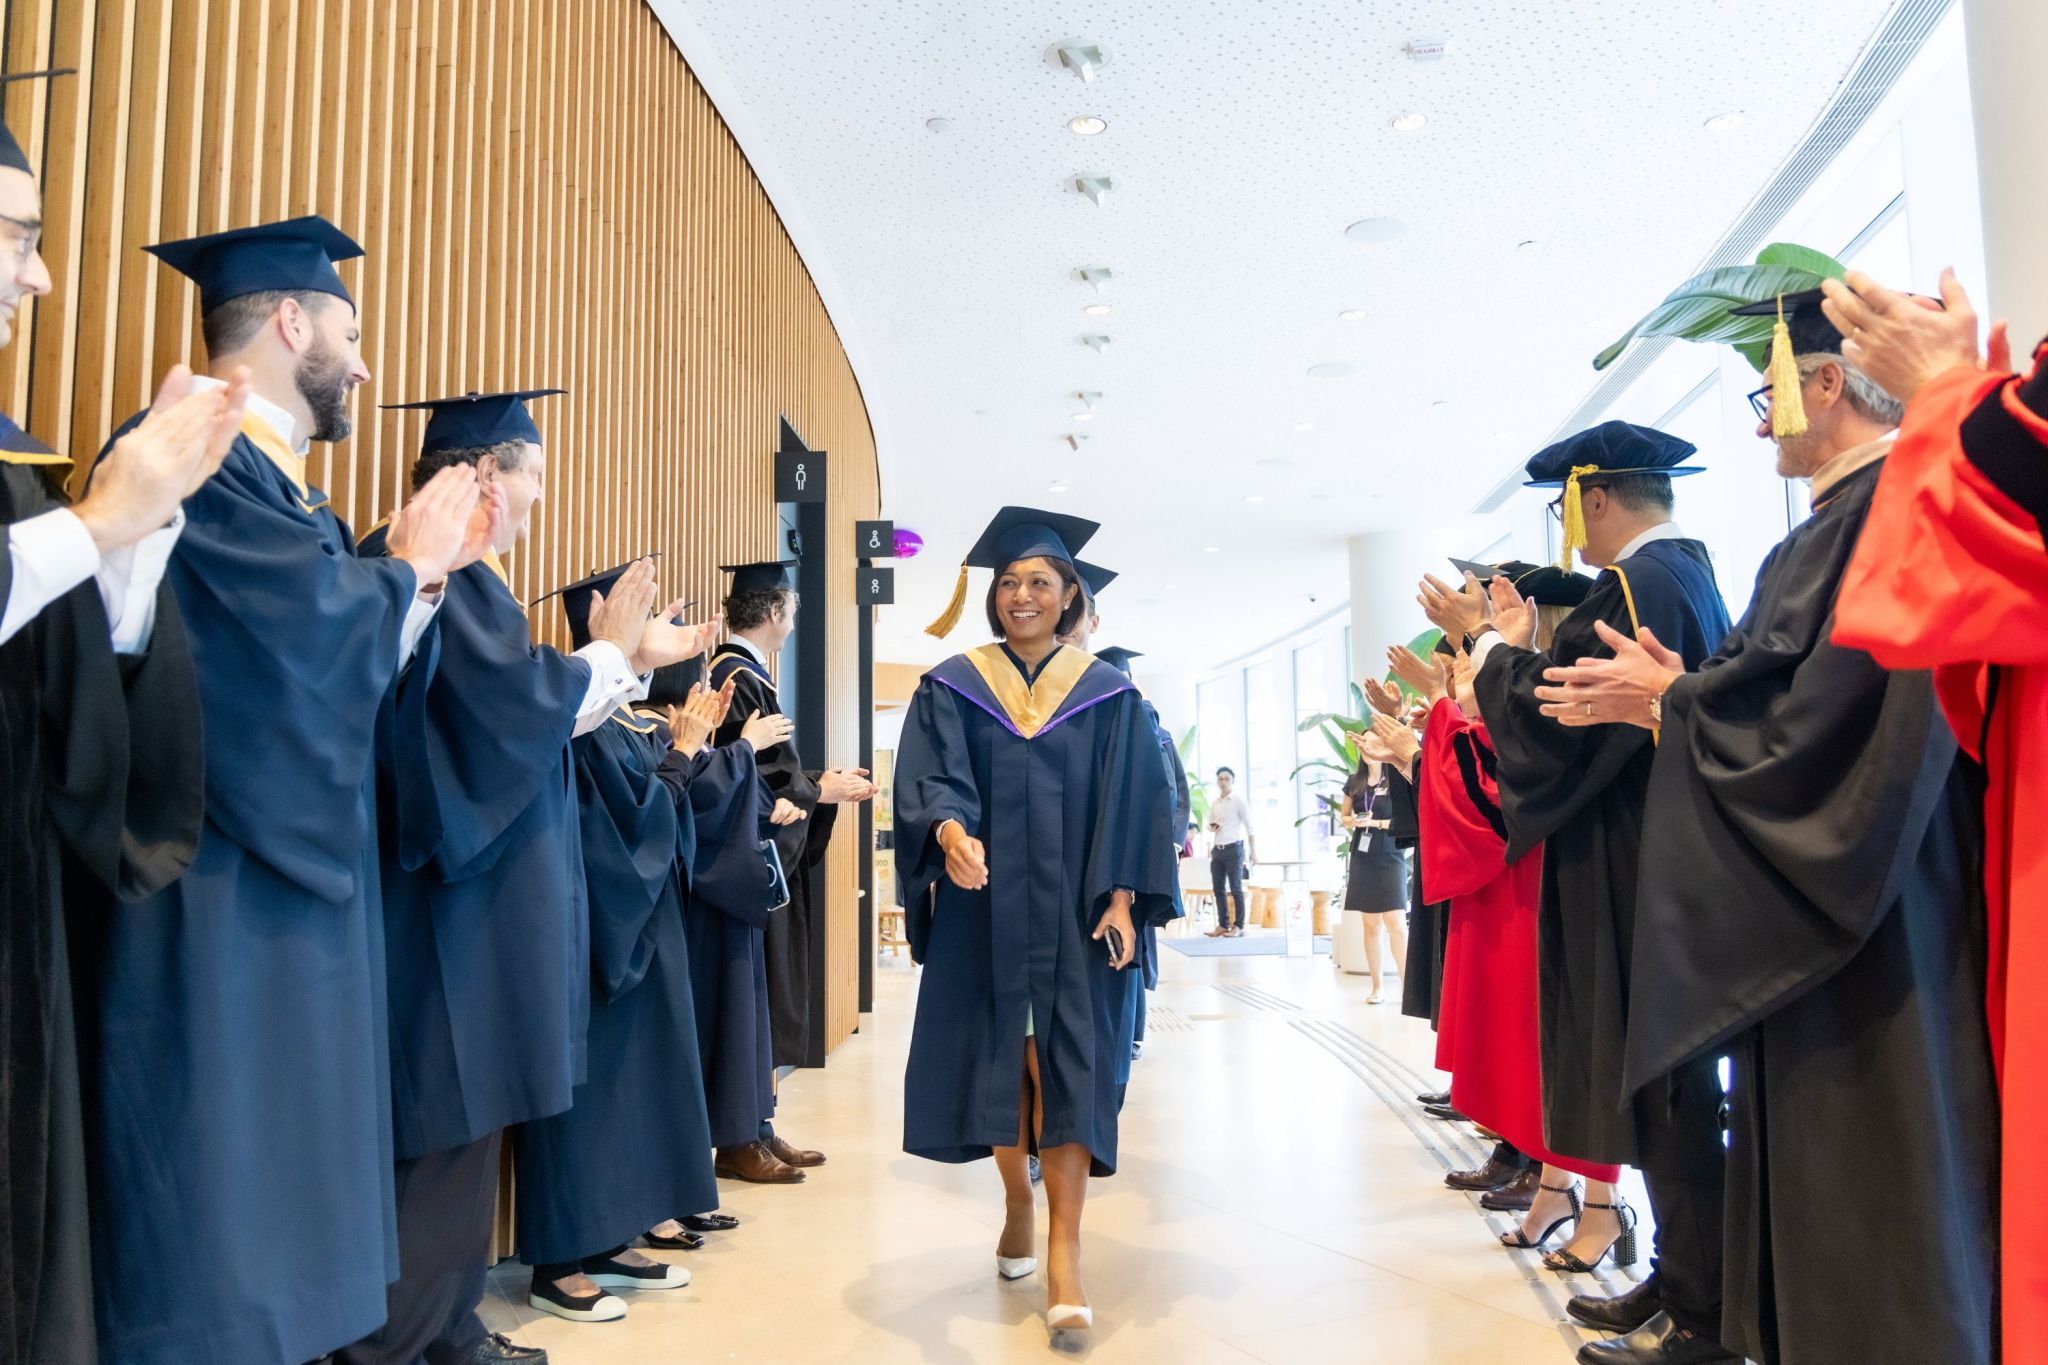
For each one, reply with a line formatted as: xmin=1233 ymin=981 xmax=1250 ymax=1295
xmin=360 ymin=530 xmax=590 ymax=1160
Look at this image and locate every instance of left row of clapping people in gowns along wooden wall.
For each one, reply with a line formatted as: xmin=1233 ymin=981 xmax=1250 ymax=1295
xmin=0 ymin=72 xmax=874 ymax=1365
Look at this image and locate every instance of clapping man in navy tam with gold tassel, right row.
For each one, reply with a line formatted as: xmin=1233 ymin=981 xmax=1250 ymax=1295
xmin=1421 ymin=422 xmax=1733 ymax=1365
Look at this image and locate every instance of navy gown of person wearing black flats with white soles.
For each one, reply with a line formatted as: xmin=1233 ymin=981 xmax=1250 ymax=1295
xmin=514 ymin=710 xmax=733 ymax=1265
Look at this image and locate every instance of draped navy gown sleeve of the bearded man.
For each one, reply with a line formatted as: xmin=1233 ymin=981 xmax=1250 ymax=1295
xmin=102 ymin=422 xmax=420 ymax=902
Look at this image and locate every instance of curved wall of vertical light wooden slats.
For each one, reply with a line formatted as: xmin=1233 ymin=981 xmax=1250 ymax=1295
xmin=0 ymin=0 xmax=879 ymax=1044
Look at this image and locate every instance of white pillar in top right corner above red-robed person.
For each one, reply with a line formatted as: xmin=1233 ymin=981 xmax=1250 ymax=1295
xmin=1962 ymin=0 xmax=2048 ymax=347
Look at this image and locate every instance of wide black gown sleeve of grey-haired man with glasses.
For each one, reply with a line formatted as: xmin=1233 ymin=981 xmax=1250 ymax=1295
xmin=1622 ymin=469 xmax=1956 ymax=1091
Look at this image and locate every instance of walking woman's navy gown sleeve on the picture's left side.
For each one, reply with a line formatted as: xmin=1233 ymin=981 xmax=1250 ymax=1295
xmin=895 ymin=677 xmax=981 ymax=964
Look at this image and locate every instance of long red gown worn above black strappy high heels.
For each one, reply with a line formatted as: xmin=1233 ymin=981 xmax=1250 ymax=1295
xmin=1417 ymin=702 xmax=1622 ymax=1181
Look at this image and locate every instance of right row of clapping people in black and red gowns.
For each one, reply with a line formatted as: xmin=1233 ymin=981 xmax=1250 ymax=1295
xmin=1360 ymin=258 xmax=2048 ymax=1365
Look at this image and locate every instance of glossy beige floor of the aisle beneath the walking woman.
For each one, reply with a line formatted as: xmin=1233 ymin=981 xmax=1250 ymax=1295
xmin=485 ymin=954 xmax=1640 ymax=1365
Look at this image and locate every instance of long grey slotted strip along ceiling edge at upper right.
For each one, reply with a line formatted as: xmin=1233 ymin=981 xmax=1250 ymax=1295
xmin=1473 ymin=0 xmax=1956 ymax=512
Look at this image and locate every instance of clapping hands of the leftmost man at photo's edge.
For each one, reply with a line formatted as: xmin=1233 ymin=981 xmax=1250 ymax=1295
xmin=72 ymin=364 xmax=250 ymax=555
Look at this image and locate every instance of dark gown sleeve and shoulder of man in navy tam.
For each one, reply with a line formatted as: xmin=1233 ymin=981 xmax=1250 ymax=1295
xmin=1474 ymin=555 xmax=1726 ymax=859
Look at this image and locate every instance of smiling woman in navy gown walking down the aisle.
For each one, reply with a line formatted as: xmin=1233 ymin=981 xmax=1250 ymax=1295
xmin=895 ymin=508 xmax=1174 ymax=1330
